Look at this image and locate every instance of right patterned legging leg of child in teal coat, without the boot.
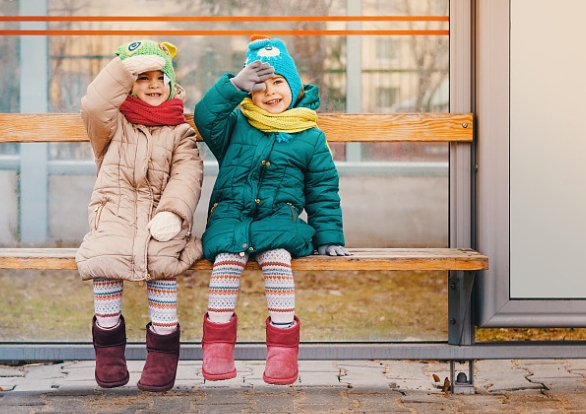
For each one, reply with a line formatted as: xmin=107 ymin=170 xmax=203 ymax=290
xmin=256 ymin=249 xmax=295 ymax=328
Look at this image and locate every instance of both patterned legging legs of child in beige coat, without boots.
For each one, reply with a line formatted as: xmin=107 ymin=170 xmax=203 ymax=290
xmin=94 ymin=279 xmax=178 ymax=335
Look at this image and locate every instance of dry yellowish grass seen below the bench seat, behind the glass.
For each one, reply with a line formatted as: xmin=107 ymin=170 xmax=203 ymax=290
xmin=0 ymin=271 xmax=586 ymax=342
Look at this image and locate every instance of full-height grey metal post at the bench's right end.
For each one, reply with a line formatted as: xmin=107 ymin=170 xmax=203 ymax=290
xmin=448 ymin=0 xmax=474 ymax=394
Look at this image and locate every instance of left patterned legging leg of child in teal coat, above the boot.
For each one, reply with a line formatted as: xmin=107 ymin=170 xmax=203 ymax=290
xmin=207 ymin=253 xmax=248 ymax=323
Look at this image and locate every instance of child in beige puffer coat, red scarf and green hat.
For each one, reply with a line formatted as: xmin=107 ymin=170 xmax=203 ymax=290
xmin=76 ymin=40 xmax=203 ymax=391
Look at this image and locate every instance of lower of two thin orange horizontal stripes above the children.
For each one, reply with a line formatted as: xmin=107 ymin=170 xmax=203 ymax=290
xmin=0 ymin=30 xmax=450 ymax=36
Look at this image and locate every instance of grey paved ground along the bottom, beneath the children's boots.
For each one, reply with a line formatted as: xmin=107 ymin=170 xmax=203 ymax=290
xmin=0 ymin=359 xmax=586 ymax=414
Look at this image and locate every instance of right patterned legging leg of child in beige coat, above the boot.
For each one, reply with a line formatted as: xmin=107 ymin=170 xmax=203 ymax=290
xmin=147 ymin=279 xmax=178 ymax=335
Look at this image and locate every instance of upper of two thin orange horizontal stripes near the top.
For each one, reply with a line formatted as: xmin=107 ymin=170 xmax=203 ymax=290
xmin=0 ymin=16 xmax=450 ymax=23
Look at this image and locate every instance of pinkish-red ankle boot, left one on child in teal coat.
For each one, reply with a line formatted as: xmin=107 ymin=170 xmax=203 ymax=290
xmin=201 ymin=313 xmax=238 ymax=381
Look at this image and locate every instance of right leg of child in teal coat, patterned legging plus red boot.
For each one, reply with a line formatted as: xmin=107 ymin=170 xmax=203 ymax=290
xmin=256 ymin=249 xmax=301 ymax=385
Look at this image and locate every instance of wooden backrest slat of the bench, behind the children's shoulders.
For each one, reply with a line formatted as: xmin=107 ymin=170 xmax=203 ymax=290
xmin=0 ymin=113 xmax=474 ymax=143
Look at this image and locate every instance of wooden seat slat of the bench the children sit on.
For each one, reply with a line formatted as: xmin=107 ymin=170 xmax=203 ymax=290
xmin=0 ymin=248 xmax=488 ymax=271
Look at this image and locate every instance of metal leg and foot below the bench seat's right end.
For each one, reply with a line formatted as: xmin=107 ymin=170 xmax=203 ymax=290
xmin=448 ymin=271 xmax=475 ymax=394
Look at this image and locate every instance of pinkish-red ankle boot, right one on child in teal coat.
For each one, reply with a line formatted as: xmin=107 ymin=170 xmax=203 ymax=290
xmin=262 ymin=316 xmax=301 ymax=385
